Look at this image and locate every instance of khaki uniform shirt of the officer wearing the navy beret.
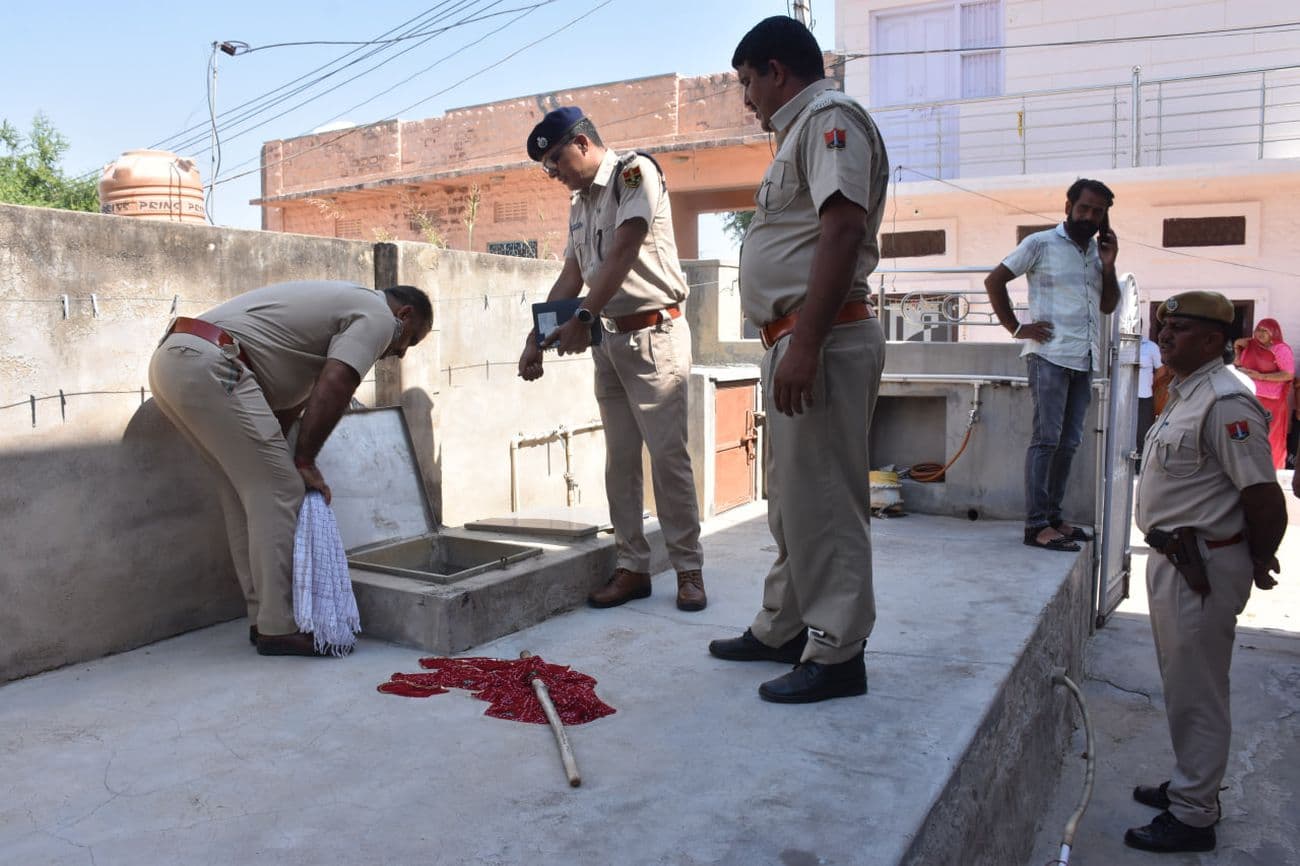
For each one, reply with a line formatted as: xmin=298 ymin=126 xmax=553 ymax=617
xmin=564 ymin=150 xmax=688 ymax=317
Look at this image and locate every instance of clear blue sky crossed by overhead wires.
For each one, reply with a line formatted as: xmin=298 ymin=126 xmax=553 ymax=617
xmin=0 ymin=0 xmax=835 ymax=249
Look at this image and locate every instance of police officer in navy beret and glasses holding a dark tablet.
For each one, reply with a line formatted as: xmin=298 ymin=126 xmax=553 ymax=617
xmin=519 ymin=105 xmax=709 ymax=611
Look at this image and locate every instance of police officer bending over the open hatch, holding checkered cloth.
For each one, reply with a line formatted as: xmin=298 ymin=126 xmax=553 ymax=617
xmin=150 ymin=281 xmax=433 ymax=655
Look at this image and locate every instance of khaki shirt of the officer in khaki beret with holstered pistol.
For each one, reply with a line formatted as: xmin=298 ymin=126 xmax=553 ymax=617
xmin=1138 ymin=359 xmax=1277 ymax=541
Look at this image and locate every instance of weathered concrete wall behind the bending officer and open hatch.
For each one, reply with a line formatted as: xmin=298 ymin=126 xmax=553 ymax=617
xmin=0 ymin=205 xmax=605 ymax=681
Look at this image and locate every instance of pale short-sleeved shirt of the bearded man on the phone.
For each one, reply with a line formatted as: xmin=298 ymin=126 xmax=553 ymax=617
xmin=1002 ymin=222 xmax=1101 ymax=372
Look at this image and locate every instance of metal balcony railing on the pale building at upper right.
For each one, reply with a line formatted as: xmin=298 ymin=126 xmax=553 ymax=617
xmin=871 ymin=66 xmax=1300 ymax=181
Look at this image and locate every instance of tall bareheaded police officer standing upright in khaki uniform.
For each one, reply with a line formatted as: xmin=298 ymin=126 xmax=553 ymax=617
xmin=709 ymin=16 xmax=889 ymax=703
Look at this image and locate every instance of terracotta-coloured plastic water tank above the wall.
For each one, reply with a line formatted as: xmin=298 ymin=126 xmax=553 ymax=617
xmin=99 ymin=151 xmax=207 ymax=222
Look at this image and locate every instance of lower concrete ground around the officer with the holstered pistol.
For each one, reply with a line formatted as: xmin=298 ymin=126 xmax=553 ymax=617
xmin=1027 ymin=473 xmax=1300 ymax=866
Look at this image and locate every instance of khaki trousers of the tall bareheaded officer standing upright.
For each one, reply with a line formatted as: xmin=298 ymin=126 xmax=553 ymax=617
xmin=750 ymin=320 xmax=885 ymax=664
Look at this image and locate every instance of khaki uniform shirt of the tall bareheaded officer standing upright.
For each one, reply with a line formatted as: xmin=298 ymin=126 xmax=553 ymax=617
xmin=740 ymin=81 xmax=889 ymax=326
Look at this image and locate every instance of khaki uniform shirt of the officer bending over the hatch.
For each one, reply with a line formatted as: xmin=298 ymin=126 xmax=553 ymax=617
xmin=199 ymin=281 xmax=402 ymax=411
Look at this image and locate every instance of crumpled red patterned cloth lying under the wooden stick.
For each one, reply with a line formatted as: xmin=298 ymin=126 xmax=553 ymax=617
xmin=378 ymin=655 xmax=616 ymax=724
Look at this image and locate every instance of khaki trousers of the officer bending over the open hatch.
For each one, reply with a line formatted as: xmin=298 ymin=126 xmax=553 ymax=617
xmin=150 ymin=334 xmax=306 ymax=635
